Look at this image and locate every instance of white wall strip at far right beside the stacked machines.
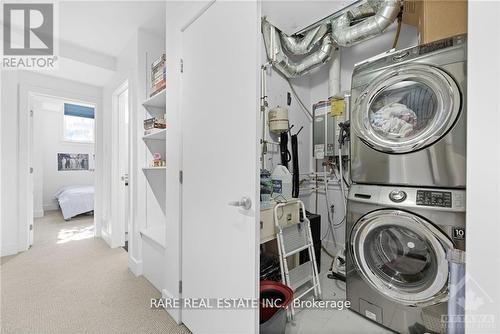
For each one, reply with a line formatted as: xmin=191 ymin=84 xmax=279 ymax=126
xmin=465 ymin=1 xmax=500 ymax=333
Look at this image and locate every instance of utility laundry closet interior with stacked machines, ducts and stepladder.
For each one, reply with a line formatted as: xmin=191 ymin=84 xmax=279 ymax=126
xmin=258 ymin=0 xmax=467 ymax=333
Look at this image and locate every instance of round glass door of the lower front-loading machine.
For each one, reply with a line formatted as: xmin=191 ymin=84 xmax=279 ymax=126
xmin=350 ymin=210 xmax=453 ymax=306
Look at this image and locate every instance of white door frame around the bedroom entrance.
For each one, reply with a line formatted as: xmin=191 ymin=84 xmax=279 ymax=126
xmin=17 ymin=84 xmax=103 ymax=252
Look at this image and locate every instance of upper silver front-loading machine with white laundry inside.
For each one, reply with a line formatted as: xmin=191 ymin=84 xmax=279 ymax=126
xmin=350 ymin=36 xmax=467 ymax=188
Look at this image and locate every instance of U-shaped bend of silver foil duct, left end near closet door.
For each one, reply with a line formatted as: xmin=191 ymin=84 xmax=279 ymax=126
xmin=262 ymin=18 xmax=333 ymax=78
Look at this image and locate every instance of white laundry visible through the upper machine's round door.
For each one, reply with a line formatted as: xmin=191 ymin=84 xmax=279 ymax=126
xmin=371 ymin=102 xmax=417 ymax=138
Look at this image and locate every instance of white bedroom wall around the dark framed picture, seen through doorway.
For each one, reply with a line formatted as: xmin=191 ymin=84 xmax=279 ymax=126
xmin=33 ymin=101 xmax=94 ymax=215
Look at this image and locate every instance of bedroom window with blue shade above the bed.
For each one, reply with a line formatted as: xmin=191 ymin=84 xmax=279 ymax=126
xmin=64 ymin=103 xmax=95 ymax=143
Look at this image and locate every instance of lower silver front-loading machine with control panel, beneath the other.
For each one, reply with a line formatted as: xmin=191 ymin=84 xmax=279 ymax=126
xmin=346 ymin=185 xmax=465 ymax=334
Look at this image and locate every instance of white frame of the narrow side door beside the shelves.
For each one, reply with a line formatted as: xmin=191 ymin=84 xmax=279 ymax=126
xmin=108 ymin=79 xmax=132 ymax=248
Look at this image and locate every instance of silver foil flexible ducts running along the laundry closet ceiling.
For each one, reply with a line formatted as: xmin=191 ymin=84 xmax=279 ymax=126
xmin=262 ymin=0 xmax=401 ymax=78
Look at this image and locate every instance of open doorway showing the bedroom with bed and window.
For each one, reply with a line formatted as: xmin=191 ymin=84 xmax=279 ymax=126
xmin=26 ymin=93 xmax=96 ymax=246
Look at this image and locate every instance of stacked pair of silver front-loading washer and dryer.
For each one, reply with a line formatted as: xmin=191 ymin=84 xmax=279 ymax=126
xmin=346 ymin=36 xmax=467 ymax=333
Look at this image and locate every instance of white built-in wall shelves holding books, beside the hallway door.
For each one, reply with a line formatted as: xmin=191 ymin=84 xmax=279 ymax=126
xmin=139 ymin=51 xmax=167 ymax=291
